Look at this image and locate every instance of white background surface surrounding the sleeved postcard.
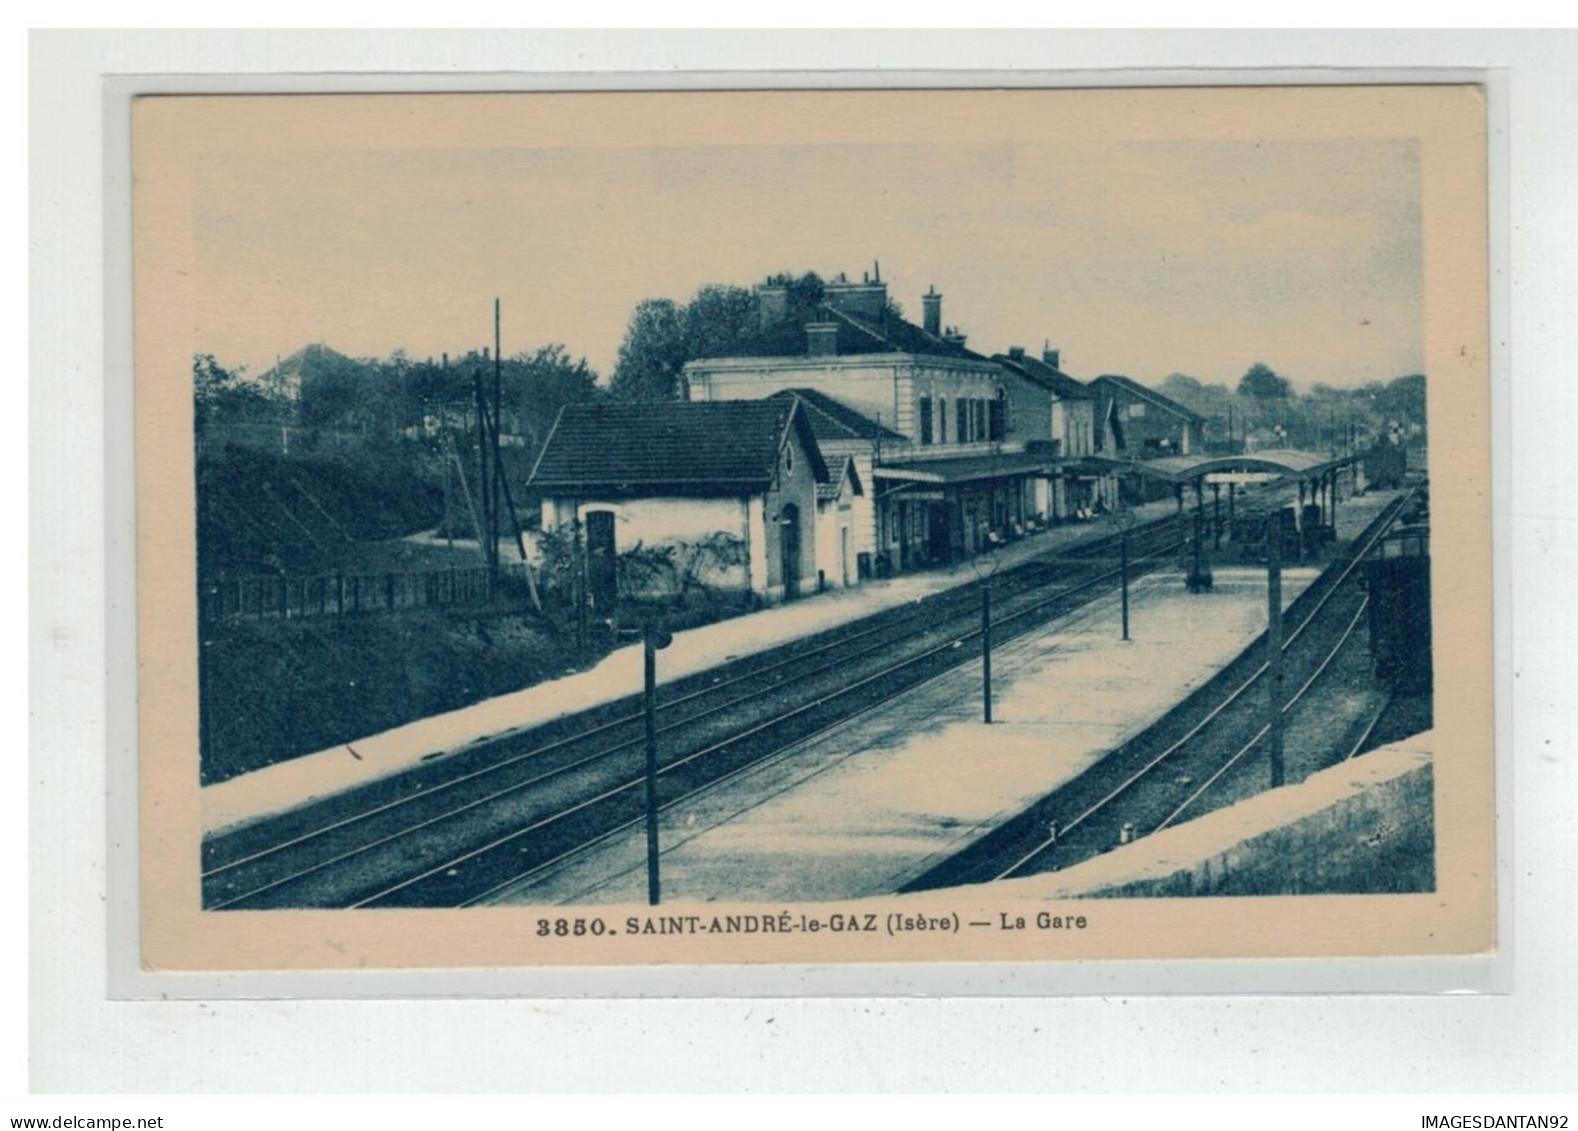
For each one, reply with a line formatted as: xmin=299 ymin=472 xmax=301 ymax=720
xmin=21 ymin=32 xmax=1578 ymax=1091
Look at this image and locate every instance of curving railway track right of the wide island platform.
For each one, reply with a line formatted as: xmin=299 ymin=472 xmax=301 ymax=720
xmin=903 ymin=494 xmax=1412 ymax=891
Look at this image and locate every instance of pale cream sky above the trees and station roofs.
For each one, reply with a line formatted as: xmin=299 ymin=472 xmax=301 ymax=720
xmin=175 ymin=89 xmax=1423 ymax=386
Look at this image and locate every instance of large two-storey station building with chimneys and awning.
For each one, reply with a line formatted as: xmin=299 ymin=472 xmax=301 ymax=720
xmin=685 ymin=273 xmax=1117 ymax=577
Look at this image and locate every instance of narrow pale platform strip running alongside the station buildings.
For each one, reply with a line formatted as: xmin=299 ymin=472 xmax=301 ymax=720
xmin=202 ymin=500 xmax=1176 ymax=833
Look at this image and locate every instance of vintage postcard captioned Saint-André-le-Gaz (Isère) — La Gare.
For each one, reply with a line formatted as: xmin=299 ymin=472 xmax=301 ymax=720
xmin=131 ymin=85 xmax=1498 ymax=972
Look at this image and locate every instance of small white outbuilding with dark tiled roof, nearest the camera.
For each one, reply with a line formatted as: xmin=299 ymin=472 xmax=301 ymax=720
xmin=527 ymin=399 xmax=833 ymax=607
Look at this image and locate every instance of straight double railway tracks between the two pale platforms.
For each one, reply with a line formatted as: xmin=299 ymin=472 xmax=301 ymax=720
xmin=202 ymin=485 xmax=1300 ymax=910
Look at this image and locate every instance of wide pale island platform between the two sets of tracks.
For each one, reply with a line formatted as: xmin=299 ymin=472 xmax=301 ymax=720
xmin=495 ymin=568 xmax=1318 ymax=904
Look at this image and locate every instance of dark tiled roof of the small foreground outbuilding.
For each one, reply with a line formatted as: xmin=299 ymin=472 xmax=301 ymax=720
xmin=527 ymin=399 xmax=828 ymax=495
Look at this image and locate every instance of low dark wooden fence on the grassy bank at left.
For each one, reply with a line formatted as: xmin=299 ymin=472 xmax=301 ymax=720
xmin=199 ymin=565 xmax=524 ymax=625
